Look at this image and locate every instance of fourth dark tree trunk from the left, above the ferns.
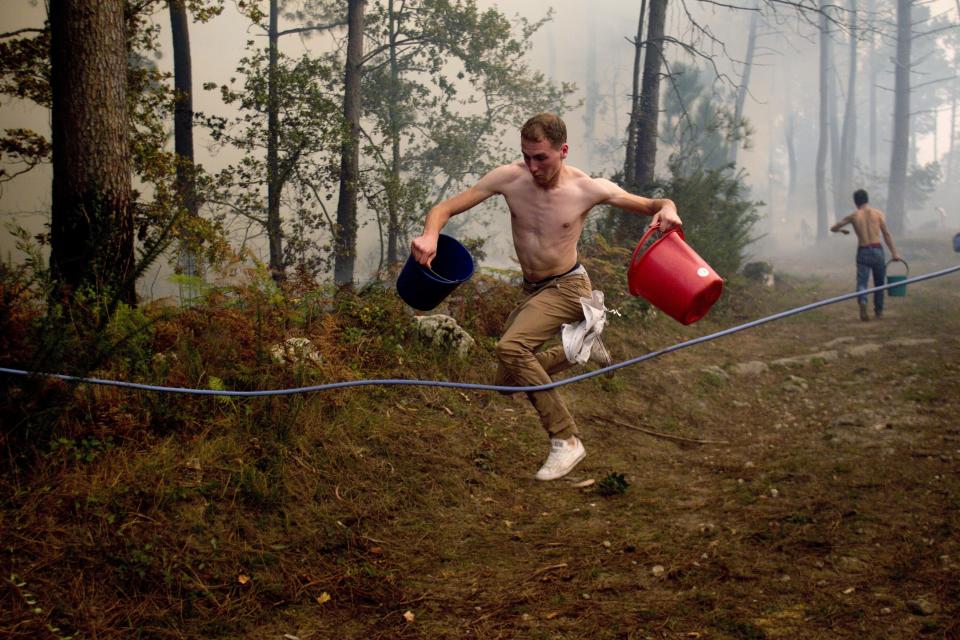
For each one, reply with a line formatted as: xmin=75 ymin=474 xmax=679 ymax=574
xmin=333 ymin=0 xmax=366 ymax=285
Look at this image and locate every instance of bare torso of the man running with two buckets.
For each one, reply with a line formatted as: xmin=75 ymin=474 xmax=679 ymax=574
xmin=495 ymin=161 xmax=605 ymax=281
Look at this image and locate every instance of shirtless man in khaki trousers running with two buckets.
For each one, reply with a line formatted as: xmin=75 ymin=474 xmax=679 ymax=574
xmin=411 ymin=113 xmax=682 ymax=480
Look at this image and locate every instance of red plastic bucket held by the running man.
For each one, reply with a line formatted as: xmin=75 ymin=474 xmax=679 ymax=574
xmin=627 ymin=225 xmax=723 ymax=324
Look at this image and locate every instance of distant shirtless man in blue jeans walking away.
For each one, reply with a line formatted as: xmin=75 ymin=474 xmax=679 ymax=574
xmin=830 ymin=189 xmax=901 ymax=321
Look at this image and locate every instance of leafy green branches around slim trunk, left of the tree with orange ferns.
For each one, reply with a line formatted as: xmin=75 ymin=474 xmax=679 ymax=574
xmin=198 ymin=41 xmax=342 ymax=275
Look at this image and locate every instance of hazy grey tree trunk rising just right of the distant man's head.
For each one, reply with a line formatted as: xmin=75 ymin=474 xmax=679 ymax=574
xmin=887 ymin=0 xmax=911 ymax=234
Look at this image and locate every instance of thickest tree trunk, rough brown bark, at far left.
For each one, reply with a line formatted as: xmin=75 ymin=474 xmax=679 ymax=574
xmin=50 ymin=0 xmax=136 ymax=305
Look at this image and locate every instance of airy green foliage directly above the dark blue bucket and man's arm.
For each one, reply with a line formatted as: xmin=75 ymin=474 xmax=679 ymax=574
xmin=364 ymin=0 xmax=573 ymax=259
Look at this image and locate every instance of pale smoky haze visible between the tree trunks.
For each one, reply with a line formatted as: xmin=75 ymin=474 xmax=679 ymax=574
xmin=0 ymin=0 xmax=960 ymax=298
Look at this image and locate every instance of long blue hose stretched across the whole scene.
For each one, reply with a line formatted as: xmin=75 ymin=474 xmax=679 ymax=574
xmin=0 ymin=265 xmax=960 ymax=398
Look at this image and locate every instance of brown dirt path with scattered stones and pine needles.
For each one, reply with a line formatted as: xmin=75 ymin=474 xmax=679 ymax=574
xmin=262 ymin=240 xmax=960 ymax=640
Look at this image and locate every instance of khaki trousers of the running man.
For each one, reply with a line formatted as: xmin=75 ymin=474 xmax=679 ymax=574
xmin=496 ymin=267 xmax=592 ymax=439
